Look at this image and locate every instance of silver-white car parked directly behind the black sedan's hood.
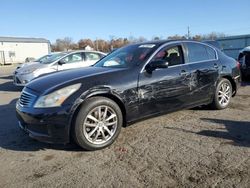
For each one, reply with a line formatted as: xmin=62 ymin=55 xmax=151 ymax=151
xmin=13 ymin=51 xmax=106 ymax=86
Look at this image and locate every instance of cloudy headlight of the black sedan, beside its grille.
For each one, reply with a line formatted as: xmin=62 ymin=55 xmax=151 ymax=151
xmin=34 ymin=83 xmax=81 ymax=108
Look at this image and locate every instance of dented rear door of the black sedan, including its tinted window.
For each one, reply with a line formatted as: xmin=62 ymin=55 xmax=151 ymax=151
xmin=184 ymin=42 xmax=220 ymax=103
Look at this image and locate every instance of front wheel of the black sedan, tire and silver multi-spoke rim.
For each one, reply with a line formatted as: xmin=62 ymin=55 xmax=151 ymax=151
xmin=73 ymin=97 xmax=123 ymax=150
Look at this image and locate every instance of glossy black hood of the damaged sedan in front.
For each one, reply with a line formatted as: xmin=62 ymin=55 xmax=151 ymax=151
xmin=26 ymin=67 xmax=120 ymax=93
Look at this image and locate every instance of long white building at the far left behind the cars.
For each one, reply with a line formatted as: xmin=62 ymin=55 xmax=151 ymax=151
xmin=0 ymin=37 xmax=51 ymax=65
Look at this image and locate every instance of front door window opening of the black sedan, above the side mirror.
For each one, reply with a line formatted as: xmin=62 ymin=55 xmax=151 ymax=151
xmin=152 ymin=46 xmax=183 ymax=66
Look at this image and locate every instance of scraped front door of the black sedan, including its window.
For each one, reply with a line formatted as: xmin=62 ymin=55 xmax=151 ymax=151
xmin=138 ymin=44 xmax=190 ymax=116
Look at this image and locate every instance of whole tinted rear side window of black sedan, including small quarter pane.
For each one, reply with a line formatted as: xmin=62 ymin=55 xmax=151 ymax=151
xmin=186 ymin=43 xmax=216 ymax=63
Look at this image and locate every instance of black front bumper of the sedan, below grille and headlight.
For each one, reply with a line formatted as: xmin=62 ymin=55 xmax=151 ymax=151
xmin=16 ymin=102 xmax=71 ymax=144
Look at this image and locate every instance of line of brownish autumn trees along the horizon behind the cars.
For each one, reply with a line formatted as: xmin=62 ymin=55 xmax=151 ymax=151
xmin=51 ymin=32 xmax=226 ymax=52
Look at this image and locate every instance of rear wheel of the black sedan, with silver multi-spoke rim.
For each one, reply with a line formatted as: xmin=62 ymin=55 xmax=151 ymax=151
xmin=211 ymin=78 xmax=233 ymax=110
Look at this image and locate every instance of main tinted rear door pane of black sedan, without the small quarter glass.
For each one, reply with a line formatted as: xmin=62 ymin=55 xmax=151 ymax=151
xmin=186 ymin=43 xmax=210 ymax=63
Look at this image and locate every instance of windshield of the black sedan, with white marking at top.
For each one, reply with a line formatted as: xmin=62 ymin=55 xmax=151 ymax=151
xmin=94 ymin=44 xmax=158 ymax=68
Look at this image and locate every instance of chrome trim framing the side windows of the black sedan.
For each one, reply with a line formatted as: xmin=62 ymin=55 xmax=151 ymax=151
xmin=140 ymin=41 xmax=219 ymax=73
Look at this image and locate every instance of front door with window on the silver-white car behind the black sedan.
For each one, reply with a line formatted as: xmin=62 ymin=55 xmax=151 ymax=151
xmin=58 ymin=52 xmax=84 ymax=71
